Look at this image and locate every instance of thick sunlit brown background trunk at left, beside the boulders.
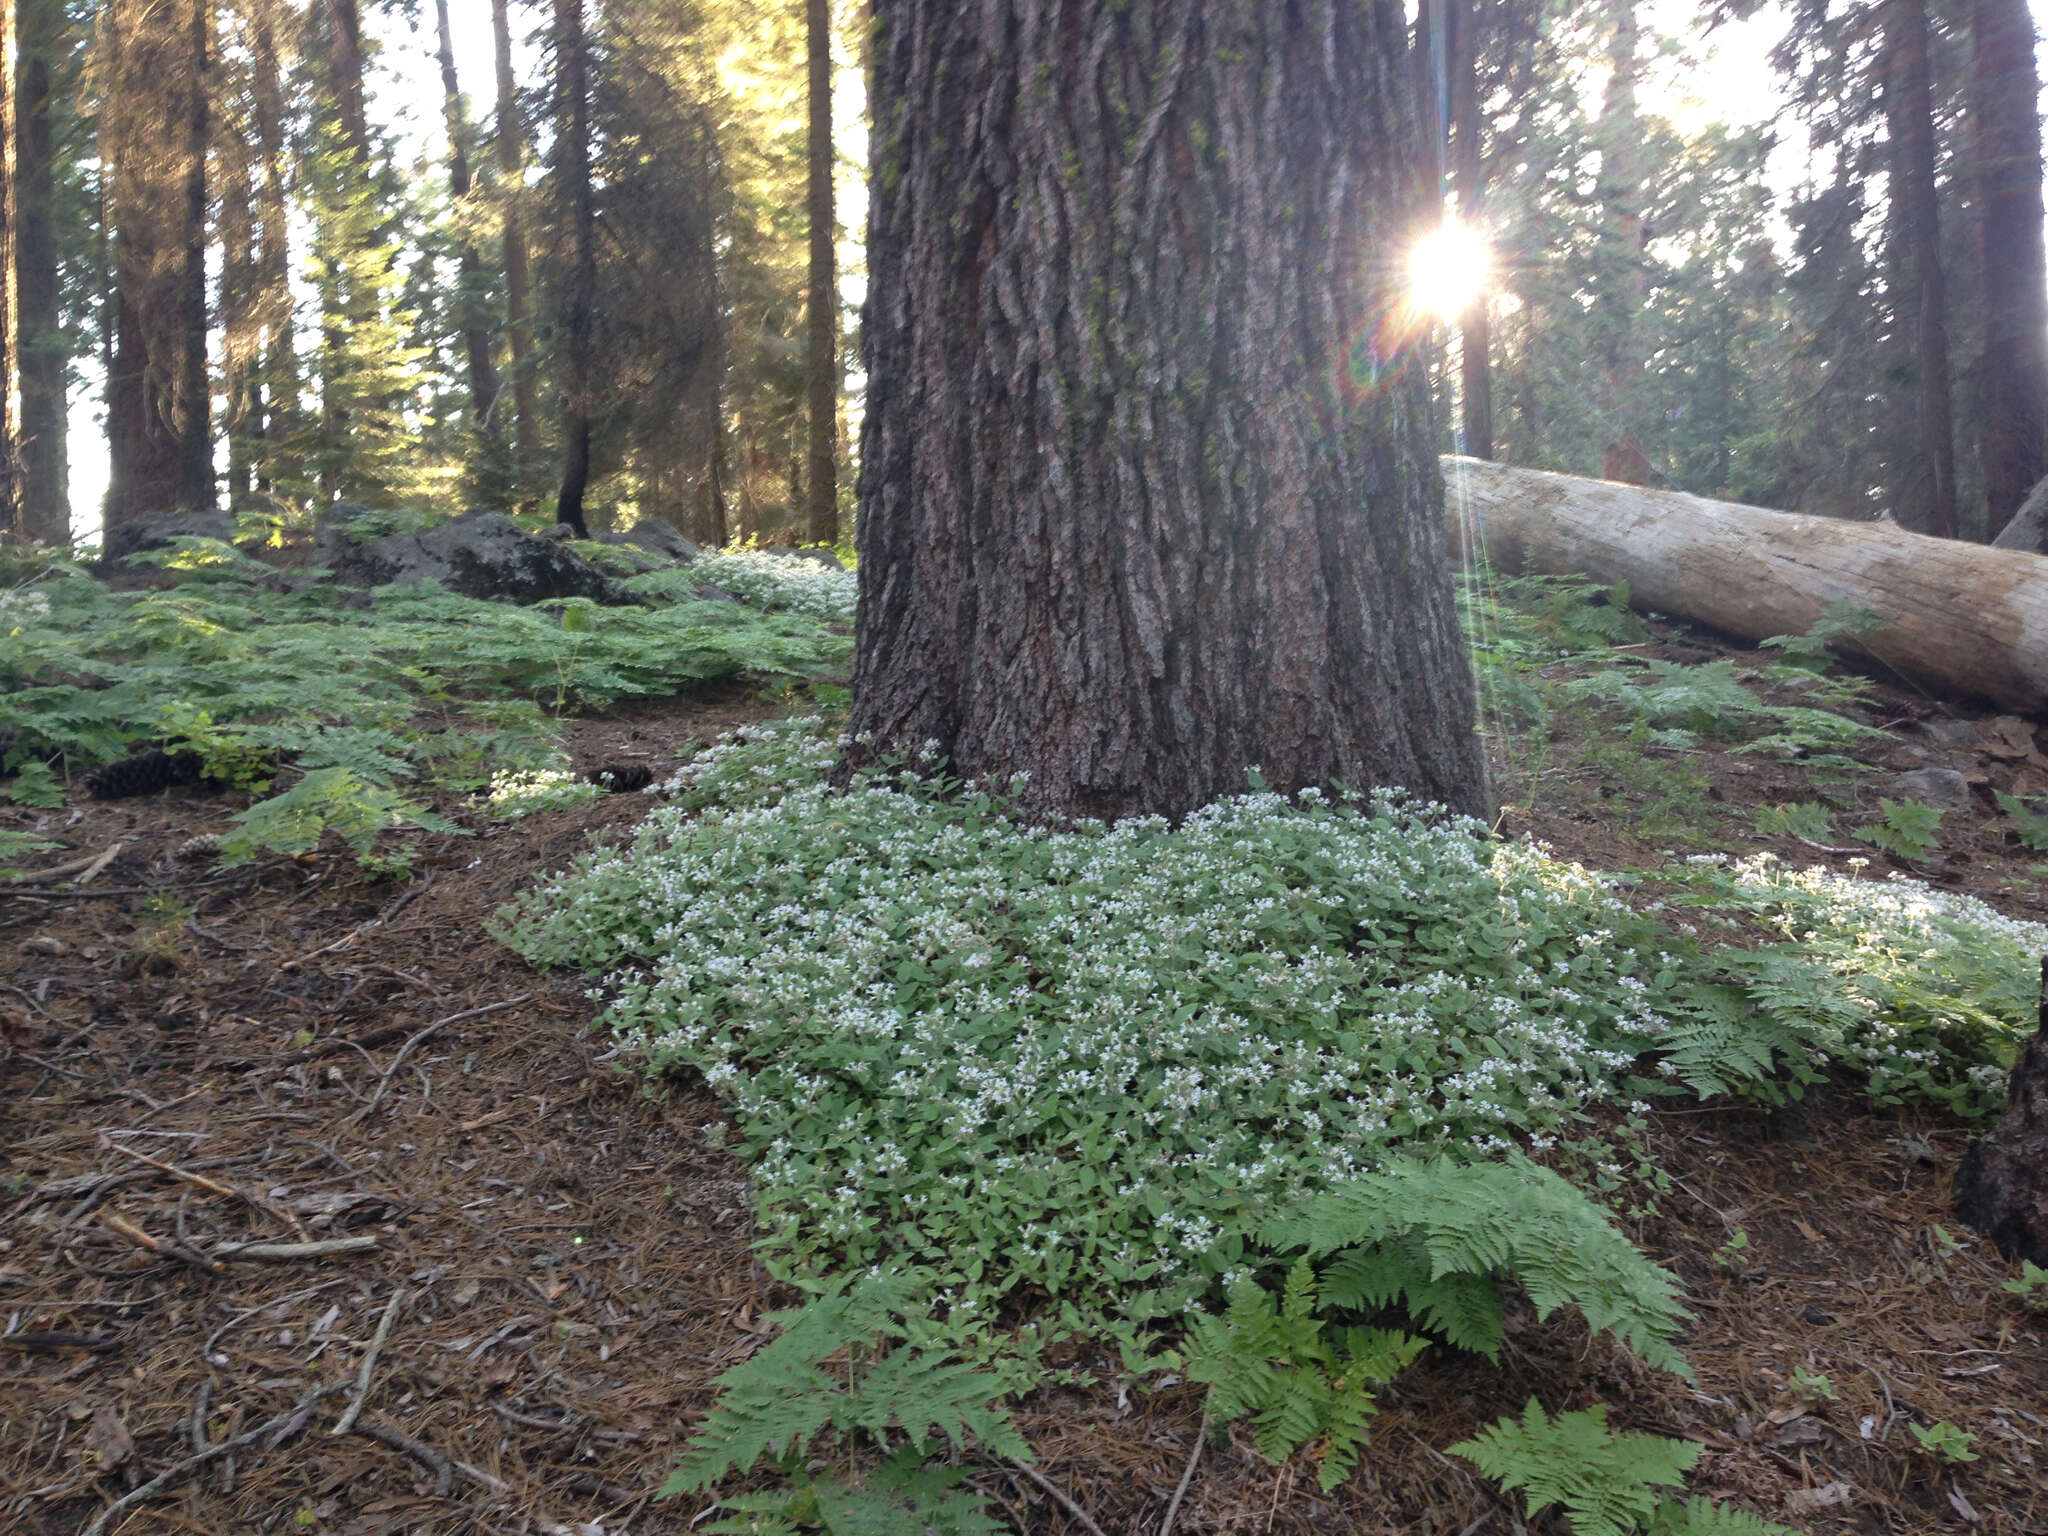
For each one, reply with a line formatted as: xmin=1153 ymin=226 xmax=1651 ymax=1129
xmin=100 ymin=0 xmax=213 ymax=528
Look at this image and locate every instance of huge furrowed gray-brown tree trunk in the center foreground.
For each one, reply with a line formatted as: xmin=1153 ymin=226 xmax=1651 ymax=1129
xmin=854 ymin=0 xmax=1489 ymax=819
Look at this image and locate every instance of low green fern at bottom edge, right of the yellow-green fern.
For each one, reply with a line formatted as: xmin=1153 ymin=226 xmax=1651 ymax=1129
xmin=1450 ymin=1397 xmax=1794 ymax=1536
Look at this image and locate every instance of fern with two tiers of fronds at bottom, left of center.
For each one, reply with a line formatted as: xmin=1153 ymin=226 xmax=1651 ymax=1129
xmin=662 ymin=1270 xmax=1030 ymax=1536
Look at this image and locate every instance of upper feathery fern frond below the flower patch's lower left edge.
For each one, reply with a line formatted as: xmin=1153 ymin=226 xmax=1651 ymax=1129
xmin=662 ymin=1274 xmax=1030 ymax=1507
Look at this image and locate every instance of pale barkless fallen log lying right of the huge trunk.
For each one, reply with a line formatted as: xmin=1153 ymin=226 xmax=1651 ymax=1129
xmin=1444 ymin=455 xmax=2048 ymax=715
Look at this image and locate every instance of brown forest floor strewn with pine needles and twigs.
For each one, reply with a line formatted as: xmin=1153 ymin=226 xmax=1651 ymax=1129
xmin=0 ymin=627 xmax=2048 ymax=1536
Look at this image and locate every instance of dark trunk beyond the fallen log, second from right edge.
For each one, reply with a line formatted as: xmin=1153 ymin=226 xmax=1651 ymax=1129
xmin=1882 ymin=0 xmax=1956 ymax=539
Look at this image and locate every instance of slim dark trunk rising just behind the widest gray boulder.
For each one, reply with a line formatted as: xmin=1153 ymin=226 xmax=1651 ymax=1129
xmin=555 ymin=0 xmax=598 ymax=537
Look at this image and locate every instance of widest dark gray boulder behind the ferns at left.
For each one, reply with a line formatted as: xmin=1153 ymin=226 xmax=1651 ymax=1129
xmin=330 ymin=510 xmax=639 ymax=606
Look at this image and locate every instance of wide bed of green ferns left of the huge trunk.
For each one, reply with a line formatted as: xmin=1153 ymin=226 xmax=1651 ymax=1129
xmin=0 ymin=541 xmax=852 ymax=872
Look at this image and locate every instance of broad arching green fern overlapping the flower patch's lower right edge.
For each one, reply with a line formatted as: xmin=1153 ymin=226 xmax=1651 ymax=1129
xmin=1262 ymin=1153 xmax=1692 ymax=1378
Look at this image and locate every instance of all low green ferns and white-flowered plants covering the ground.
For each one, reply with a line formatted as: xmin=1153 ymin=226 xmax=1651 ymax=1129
xmin=0 ymin=557 xmax=2048 ymax=1536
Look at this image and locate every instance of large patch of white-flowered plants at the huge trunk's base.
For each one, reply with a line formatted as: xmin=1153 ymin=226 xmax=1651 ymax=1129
xmin=495 ymin=721 xmax=1695 ymax=1335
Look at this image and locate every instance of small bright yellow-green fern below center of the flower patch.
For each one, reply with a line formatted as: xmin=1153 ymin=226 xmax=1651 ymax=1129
xmin=1186 ymin=1260 xmax=1427 ymax=1493
